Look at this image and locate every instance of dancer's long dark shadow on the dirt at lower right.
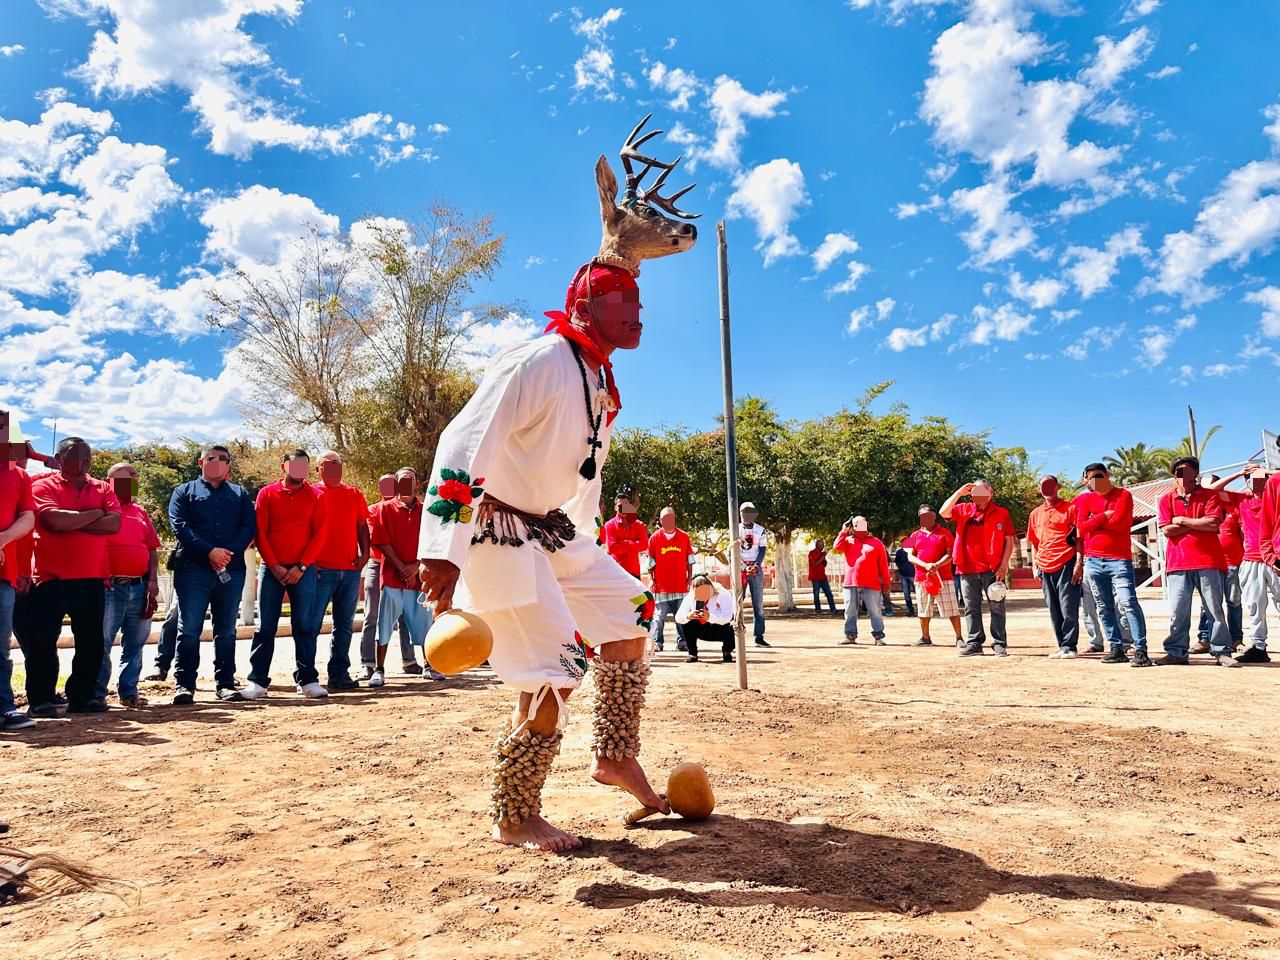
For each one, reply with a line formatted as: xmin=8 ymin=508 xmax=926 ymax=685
xmin=576 ymin=817 xmax=1280 ymax=927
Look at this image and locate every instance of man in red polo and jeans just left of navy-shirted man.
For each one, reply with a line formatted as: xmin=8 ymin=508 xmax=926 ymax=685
xmin=96 ymin=463 xmax=160 ymax=707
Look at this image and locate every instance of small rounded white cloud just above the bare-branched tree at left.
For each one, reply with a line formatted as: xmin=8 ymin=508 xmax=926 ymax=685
xmin=200 ymin=184 xmax=339 ymax=264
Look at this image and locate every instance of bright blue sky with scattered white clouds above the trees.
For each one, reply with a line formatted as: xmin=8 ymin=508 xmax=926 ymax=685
xmin=0 ymin=0 xmax=1280 ymax=474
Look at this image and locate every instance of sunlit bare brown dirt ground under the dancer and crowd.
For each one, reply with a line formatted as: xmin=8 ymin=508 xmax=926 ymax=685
xmin=0 ymin=599 xmax=1280 ymax=960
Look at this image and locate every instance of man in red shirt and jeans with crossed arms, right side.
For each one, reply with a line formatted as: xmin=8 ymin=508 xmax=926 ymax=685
xmin=1156 ymin=457 xmax=1240 ymax=667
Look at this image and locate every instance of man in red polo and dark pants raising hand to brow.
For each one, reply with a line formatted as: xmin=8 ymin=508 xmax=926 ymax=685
xmin=942 ymin=480 xmax=1014 ymax=657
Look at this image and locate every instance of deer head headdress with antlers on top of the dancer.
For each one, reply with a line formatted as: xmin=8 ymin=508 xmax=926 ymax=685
xmin=595 ymin=114 xmax=701 ymax=274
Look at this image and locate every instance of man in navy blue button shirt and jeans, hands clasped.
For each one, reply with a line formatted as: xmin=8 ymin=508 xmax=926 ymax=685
xmin=169 ymin=447 xmax=256 ymax=707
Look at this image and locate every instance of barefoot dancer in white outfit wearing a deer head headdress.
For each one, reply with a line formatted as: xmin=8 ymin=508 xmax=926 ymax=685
xmin=419 ymin=116 xmax=698 ymax=851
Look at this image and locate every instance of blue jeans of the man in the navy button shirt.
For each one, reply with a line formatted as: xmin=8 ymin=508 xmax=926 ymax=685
xmin=173 ymin=563 xmax=244 ymax=690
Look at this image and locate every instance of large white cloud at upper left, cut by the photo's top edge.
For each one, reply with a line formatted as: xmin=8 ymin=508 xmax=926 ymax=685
xmin=52 ymin=0 xmax=412 ymax=159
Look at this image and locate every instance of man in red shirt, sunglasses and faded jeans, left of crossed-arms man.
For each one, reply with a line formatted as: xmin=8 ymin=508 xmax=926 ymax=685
xmin=1071 ymin=463 xmax=1151 ymax=667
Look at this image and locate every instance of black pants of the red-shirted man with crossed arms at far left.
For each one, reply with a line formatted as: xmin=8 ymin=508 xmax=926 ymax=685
xmin=27 ymin=580 xmax=106 ymax=707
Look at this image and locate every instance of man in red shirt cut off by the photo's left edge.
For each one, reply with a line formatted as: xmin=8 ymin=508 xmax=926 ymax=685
xmin=0 ymin=410 xmax=36 ymax=733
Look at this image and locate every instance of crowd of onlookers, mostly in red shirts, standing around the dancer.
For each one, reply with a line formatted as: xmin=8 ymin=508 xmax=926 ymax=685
xmin=0 ymin=417 xmax=1280 ymax=730
